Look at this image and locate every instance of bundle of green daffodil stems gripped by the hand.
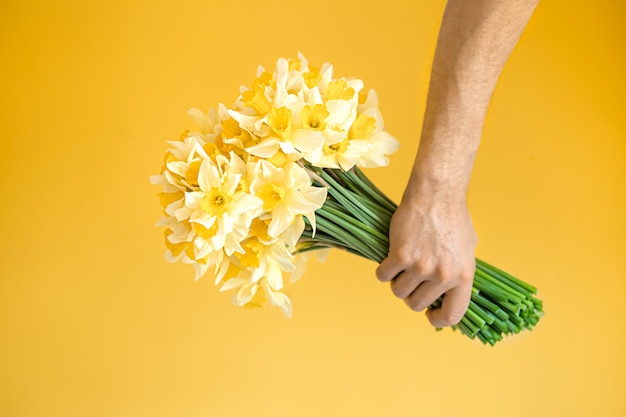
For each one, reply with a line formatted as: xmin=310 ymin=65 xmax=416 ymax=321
xmin=300 ymin=163 xmax=543 ymax=346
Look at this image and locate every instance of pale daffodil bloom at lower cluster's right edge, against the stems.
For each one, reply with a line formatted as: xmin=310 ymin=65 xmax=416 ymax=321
xmin=250 ymin=160 xmax=326 ymax=237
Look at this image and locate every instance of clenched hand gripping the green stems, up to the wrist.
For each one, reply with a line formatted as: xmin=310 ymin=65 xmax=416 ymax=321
xmin=376 ymin=192 xmax=477 ymax=327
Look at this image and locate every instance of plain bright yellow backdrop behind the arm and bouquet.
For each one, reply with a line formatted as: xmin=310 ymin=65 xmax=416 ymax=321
xmin=0 ymin=0 xmax=626 ymax=417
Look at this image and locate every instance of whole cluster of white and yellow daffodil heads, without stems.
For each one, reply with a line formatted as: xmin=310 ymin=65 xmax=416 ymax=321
xmin=150 ymin=53 xmax=398 ymax=316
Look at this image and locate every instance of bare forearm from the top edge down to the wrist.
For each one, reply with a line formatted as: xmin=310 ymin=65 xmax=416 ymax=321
xmin=405 ymin=0 xmax=538 ymax=198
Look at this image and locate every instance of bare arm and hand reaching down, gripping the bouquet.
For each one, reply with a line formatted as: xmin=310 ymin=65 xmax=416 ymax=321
xmin=376 ymin=0 xmax=538 ymax=327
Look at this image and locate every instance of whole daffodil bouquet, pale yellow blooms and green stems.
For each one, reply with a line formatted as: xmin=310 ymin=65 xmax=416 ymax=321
xmin=151 ymin=54 xmax=542 ymax=345
